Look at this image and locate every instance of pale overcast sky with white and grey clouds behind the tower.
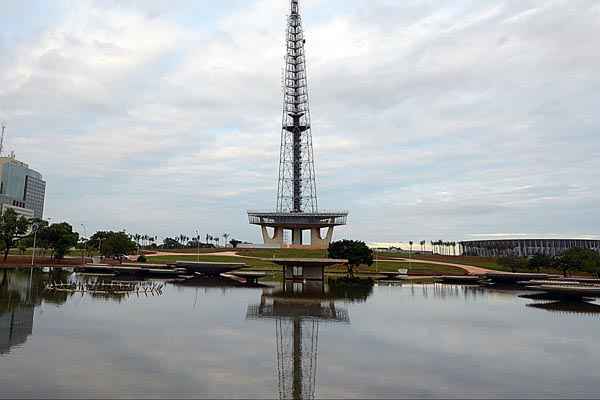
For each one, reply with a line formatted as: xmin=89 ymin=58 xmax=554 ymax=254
xmin=0 ymin=0 xmax=600 ymax=242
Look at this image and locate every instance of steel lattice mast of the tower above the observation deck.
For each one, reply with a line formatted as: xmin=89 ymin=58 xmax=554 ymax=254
xmin=277 ymin=0 xmax=318 ymax=213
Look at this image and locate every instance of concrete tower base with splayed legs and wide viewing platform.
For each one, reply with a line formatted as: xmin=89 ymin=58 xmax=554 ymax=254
xmin=248 ymin=211 xmax=348 ymax=249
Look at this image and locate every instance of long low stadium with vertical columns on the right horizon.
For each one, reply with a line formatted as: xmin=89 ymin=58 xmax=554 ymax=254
xmin=460 ymin=239 xmax=600 ymax=257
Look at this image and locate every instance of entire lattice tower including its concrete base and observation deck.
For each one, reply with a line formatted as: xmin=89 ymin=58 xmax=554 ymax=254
xmin=248 ymin=0 xmax=348 ymax=249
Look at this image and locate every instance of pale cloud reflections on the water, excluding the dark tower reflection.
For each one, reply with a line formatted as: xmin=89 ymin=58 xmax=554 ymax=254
xmin=0 ymin=276 xmax=600 ymax=398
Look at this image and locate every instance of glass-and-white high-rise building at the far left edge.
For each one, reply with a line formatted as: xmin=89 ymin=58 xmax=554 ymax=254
xmin=0 ymin=156 xmax=46 ymax=218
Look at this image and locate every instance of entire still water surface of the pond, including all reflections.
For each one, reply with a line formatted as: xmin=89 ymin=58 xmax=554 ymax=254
xmin=0 ymin=271 xmax=600 ymax=398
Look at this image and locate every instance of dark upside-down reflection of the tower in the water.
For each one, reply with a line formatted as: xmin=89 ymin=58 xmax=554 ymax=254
xmin=247 ymin=282 xmax=350 ymax=399
